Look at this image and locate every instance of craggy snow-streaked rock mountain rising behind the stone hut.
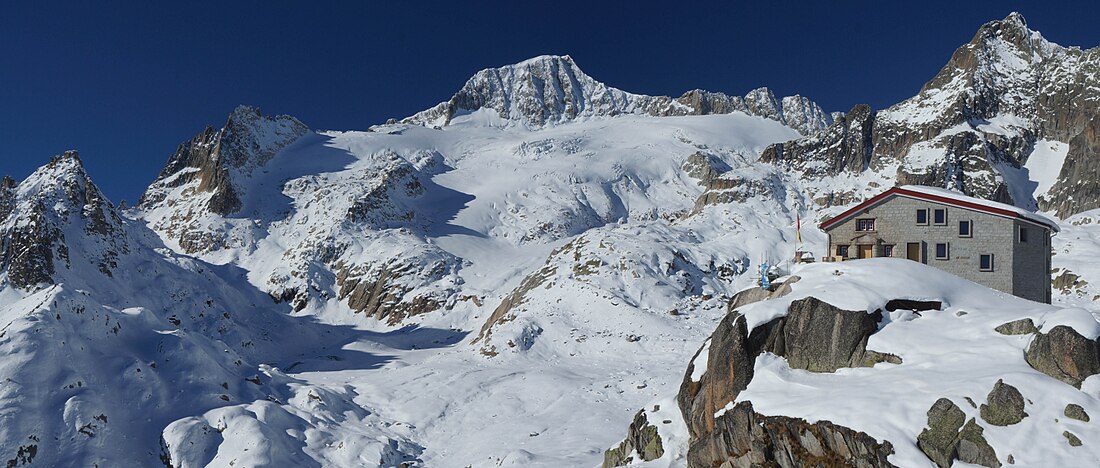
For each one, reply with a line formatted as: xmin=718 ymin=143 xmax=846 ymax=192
xmin=761 ymin=13 xmax=1100 ymax=218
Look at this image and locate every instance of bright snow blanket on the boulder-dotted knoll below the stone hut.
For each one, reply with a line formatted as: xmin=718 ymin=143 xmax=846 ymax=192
xmin=738 ymin=259 xmax=1100 ymax=467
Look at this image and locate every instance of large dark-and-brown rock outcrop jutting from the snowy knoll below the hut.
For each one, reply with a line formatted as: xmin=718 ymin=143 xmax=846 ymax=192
xmin=677 ymin=297 xmax=897 ymax=466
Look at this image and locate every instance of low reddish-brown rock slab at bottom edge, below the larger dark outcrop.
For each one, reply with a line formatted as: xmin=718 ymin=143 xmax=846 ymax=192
xmin=688 ymin=402 xmax=893 ymax=468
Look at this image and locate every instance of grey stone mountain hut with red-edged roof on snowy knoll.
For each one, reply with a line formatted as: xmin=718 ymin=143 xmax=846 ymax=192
xmin=821 ymin=185 xmax=1058 ymax=303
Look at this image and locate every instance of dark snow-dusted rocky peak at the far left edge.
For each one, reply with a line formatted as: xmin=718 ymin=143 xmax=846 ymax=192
xmin=0 ymin=151 xmax=130 ymax=290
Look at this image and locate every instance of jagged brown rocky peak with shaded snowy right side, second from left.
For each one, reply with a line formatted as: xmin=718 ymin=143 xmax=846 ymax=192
xmin=139 ymin=106 xmax=309 ymax=216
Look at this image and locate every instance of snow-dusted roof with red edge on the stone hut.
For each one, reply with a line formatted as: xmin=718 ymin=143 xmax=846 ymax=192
xmin=821 ymin=185 xmax=1059 ymax=232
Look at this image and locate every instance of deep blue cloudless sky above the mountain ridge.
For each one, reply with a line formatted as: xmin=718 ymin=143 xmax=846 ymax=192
xmin=0 ymin=0 xmax=1100 ymax=202
